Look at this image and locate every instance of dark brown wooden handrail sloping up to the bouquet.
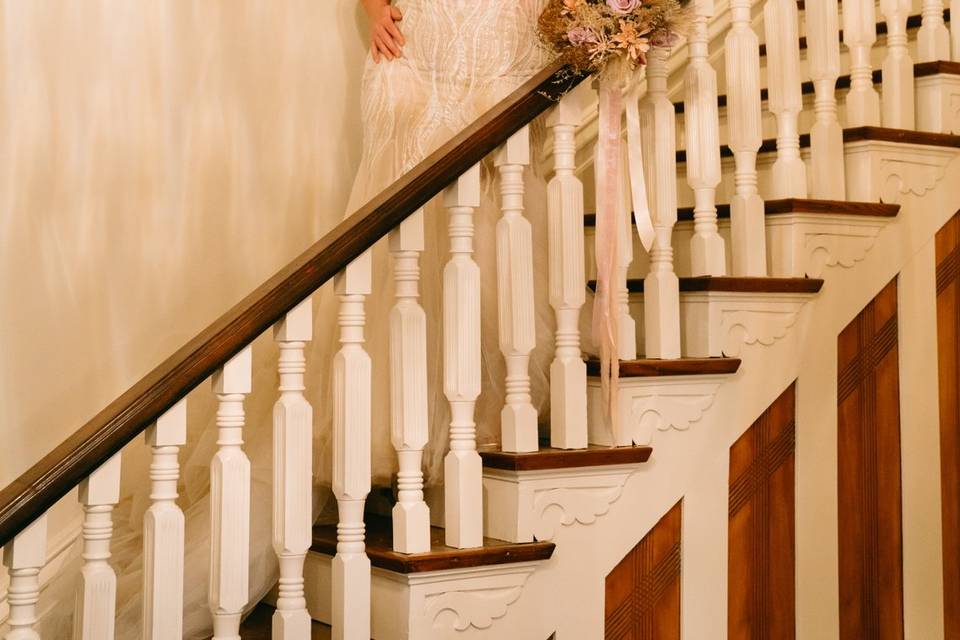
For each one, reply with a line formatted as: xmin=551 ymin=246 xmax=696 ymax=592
xmin=0 ymin=63 xmax=583 ymax=546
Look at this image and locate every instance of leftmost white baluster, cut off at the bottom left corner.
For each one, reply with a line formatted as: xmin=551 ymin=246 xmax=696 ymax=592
xmin=3 ymin=515 xmax=47 ymax=640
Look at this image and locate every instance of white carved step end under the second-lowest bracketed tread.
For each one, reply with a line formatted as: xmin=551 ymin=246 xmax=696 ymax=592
xmin=483 ymin=463 xmax=643 ymax=542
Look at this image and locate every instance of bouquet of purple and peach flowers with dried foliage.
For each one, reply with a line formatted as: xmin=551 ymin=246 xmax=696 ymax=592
xmin=539 ymin=0 xmax=690 ymax=73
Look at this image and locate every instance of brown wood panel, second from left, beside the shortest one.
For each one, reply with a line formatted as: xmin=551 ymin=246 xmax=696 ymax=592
xmin=727 ymin=384 xmax=796 ymax=640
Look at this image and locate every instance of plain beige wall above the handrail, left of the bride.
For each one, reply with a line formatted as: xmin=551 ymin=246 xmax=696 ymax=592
xmin=0 ymin=0 xmax=365 ymax=486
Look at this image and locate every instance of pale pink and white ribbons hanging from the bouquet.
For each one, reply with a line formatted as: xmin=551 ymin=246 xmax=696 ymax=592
xmin=593 ymin=73 xmax=654 ymax=440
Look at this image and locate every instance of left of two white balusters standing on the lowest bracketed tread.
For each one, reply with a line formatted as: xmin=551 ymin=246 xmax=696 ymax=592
xmin=390 ymin=209 xmax=430 ymax=553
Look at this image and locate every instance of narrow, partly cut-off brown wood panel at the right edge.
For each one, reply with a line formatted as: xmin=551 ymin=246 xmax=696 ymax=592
xmin=936 ymin=214 xmax=960 ymax=640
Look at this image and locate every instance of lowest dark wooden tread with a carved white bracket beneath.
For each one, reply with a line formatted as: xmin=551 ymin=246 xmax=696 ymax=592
xmin=311 ymin=514 xmax=555 ymax=574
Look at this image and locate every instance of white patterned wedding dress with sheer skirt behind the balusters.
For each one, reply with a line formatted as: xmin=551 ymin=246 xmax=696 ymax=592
xmin=22 ymin=0 xmax=554 ymax=640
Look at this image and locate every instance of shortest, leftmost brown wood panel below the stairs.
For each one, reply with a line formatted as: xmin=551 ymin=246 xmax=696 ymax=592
xmin=604 ymin=502 xmax=682 ymax=640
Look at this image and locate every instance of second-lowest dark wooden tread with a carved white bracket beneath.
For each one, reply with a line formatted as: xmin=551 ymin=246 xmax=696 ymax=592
xmin=479 ymin=443 xmax=653 ymax=471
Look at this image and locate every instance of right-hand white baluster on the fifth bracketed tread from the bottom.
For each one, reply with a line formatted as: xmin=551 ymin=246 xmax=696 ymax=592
xmin=804 ymin=0 xmax=846 ymax=200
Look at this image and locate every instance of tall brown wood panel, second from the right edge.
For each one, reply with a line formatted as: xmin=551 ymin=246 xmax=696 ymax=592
xmin=837 ymin=280 xmax=903 ymax=640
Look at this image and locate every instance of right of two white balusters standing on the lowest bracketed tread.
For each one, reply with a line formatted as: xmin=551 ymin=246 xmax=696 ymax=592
xmin=443 ymin=165 xmax=483 ymax=549
